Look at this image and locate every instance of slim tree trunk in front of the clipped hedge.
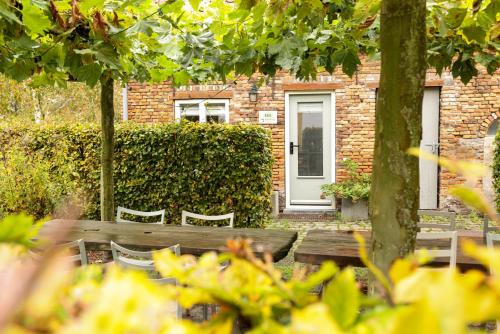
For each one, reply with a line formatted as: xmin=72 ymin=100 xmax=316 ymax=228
xmin=101 ymin=73 xmax=115 ymax=221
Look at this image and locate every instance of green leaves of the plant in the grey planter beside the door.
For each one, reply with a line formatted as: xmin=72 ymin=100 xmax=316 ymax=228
xmin=321 ymin=158 xmax=371 ymax=202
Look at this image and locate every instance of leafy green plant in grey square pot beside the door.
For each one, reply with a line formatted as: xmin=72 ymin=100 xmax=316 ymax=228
xmin=321 ymin=158 xmax=371 ymax=220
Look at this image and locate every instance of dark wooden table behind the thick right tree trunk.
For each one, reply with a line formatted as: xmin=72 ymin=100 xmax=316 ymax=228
xmin=295 ymin=230 xmax=487 ymax=271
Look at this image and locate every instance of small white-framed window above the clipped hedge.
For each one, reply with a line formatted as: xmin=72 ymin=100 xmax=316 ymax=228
xmin=175 ymin=99 xmax=229 ymax=123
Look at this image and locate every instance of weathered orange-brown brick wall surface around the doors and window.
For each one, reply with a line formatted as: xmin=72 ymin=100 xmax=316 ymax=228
xmin=128 ymin=62 xmax=500 ymax=211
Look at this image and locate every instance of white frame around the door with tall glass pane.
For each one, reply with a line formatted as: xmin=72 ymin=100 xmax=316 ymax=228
xmin=285 ymin=90 xmax=337 ymax=210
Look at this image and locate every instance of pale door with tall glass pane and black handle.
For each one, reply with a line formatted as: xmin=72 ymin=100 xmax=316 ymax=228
xmin=287 ymin=94 xmax=332 ymax=207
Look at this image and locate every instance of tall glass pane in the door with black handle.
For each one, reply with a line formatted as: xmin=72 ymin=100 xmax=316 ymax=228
xmin=297 ymin=102 xmax=323 ymax=176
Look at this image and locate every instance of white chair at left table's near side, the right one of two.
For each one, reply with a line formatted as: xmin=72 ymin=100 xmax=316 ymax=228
xmin=111 ymin=241 xmax=182 ymax=319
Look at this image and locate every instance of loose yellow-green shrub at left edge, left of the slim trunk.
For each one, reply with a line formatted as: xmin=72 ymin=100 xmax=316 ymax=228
xmin=0 ymin=143 xmax=77 ymax=218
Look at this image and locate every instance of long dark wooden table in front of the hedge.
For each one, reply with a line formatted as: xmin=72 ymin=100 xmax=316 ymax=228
xmin=41 ymin=219 xmax=297 ymax=261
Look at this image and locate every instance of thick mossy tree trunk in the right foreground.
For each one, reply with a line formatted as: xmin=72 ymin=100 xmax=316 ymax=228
xmin=370 ymin=0 xmax=426 ymax=273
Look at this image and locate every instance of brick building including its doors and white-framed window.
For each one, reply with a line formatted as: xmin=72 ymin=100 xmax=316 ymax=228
xmin=123 ymin=62 xmax=500 ymax=210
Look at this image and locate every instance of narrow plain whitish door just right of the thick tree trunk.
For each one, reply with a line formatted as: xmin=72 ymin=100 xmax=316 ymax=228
xmin=420 ymin=88 xmax=439 ymax=210
